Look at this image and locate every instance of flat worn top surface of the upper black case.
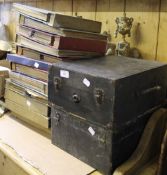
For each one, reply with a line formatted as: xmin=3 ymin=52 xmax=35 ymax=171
xmin=55 ymin=56 xmax=166 ymax=80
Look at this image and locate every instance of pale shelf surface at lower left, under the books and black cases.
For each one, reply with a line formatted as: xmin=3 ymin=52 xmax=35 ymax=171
xmin=0 ymin=113 xmax=100 ymax=175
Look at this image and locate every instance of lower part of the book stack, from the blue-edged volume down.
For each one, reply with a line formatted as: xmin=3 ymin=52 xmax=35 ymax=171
xmin=5 ymin=54 xmax=50 ymax=131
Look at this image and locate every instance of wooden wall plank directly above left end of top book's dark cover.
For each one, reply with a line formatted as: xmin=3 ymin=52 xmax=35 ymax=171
xmin=53 ymin=0 xmax=73 ymax=15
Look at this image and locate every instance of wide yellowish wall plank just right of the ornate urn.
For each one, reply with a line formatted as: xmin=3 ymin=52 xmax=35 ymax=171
xmin=126 ymin=0 xmax=160 ymax=59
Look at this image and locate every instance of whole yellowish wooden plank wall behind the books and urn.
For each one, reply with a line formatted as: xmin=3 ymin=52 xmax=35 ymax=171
xmin=0 ymin=0 xmax=167 ymax=61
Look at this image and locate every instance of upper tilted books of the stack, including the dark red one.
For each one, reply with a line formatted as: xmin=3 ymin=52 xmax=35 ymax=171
xmin=14 ymin=4 xmax=107 ymax=59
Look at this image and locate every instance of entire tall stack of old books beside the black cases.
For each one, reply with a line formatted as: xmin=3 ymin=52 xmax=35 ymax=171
xmin=5 ymin=4 xmax=107 ymax=131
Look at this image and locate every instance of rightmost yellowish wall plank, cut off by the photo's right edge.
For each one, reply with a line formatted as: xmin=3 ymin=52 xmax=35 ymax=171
xmin=157 ymin=0 xmax=167 ymax=62
